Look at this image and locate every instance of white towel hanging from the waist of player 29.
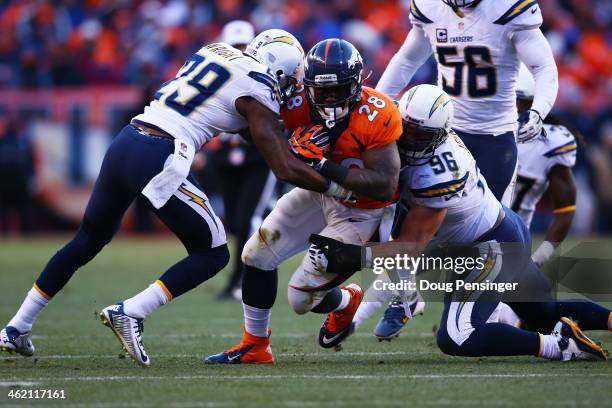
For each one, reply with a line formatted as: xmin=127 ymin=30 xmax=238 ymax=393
xmin=142 ymin=139 xmax=195 ymax=209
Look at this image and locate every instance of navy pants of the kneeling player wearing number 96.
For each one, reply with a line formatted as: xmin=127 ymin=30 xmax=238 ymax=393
xmin=437 ymin=208 xmax=610 ymax=357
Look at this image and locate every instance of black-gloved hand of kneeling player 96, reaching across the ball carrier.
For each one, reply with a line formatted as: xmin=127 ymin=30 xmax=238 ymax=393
xmin=310 ymin=234 xmax=362 ymax=275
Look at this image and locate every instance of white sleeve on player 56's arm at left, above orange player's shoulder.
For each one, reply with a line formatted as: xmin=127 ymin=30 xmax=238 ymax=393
xmin=376 ymin=25 xmax=432 ymax=97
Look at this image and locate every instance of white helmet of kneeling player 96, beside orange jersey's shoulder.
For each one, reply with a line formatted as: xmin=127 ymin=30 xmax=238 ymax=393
xmin=397 ymin=84 xmax=453 ymax=164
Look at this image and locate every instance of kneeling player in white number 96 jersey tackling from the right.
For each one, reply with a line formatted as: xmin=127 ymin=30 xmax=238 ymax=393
xmin=311 ymin=85 xmax=610 ymax=360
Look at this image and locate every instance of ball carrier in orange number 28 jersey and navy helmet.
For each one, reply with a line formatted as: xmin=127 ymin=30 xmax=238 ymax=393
xmin=206 ymin=39 xmax=402 ymax=364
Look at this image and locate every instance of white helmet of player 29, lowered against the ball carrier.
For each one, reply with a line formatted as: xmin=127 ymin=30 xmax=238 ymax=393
xmin=244 ymin=29 xmax=304 ymax=103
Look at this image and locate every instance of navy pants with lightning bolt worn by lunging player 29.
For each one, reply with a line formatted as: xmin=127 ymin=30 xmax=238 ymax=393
xmin=36 ymin=125 xmax=229 ymax=297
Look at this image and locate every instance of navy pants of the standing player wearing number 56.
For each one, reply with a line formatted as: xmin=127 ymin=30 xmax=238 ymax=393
xmin=455 ymin=130 xmax=518 ymax=206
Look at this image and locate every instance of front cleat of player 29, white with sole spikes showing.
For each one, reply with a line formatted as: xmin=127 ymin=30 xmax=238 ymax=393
xmin=100 ymin=302 xmax=151 ymax=366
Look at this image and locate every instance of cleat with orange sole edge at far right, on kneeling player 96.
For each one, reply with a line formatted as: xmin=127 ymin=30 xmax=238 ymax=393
xmin=553 ymin=317 xmax=608 ymax=361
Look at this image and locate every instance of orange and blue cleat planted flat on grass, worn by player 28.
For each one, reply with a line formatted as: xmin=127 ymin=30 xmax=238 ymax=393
xmin=204 ymin=330 xmax=274 ymax=364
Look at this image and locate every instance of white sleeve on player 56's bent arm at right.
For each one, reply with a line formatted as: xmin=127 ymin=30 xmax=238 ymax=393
xmin=511 ymin=28 xmax=559 ymax=119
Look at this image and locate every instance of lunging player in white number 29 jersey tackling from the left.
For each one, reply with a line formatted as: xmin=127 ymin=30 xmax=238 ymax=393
xmin=0 ymin=30 xmax=347 ymax=365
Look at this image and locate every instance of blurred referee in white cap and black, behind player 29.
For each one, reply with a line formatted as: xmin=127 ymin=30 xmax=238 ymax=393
xmin=211 ymin=20 xmax=276 ymax=300
